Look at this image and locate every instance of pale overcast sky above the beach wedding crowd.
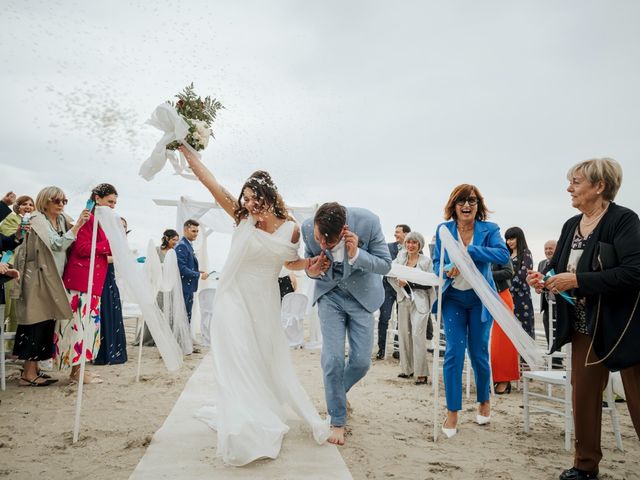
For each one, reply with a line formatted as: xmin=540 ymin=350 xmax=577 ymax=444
xmin=0 ymin=0 xmax=640 ymax=267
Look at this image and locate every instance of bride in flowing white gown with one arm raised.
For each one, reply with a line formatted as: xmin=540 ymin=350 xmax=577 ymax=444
xmin=180 ymin=147 xmax=329 ymax=466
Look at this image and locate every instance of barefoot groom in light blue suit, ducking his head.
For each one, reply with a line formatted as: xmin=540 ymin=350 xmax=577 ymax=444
xmin=302 ymin=202 xmax=391 ymax=445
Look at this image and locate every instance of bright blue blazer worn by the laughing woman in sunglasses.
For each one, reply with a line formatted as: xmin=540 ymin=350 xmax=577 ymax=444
xmin=433 ymin=220 xmax=509 ymax=322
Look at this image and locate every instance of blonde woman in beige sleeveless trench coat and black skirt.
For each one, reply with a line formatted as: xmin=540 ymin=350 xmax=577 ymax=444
xmin=11 ymin=187 xmax=89 ymax=387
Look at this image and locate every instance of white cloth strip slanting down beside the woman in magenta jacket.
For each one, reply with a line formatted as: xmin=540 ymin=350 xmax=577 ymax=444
xmin=95 ymin=207 xmax=182 ymax=372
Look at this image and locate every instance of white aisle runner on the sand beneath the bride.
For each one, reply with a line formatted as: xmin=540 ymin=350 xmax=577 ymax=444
xmin=129 ymin=355 xmax=352 ymax=480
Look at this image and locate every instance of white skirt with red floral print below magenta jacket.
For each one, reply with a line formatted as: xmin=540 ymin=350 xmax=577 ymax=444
xmin=53 ymin=290 xmax=100 ymax=370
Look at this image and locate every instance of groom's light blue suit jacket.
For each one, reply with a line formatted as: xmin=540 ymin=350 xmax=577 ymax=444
xmin=301 ymin=208 xmax=391 ymax=312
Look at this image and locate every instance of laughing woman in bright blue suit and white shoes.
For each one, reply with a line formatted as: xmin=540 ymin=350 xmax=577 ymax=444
xmin=433 ymin=184 xmax=509 ymax=438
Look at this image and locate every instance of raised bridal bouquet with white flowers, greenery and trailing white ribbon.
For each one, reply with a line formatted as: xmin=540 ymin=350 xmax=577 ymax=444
xmin=139 ymin=83 xmax=224 ymax=180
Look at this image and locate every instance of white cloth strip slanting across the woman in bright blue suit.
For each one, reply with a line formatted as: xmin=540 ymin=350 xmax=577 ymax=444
xmin=438 ymin=226 xmax=544 ymax=369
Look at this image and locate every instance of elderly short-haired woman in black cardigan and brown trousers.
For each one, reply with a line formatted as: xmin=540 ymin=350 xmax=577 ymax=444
xmin=527 ymin=158 xmax=640 ymax=480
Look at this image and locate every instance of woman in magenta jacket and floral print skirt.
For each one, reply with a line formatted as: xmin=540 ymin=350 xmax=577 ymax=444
xmin=58 ymin=183 xmax=118 ymax=383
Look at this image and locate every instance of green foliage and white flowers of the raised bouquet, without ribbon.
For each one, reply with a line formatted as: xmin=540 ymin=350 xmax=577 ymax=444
xmin=167 ymin=83 xmax=224 ymax=151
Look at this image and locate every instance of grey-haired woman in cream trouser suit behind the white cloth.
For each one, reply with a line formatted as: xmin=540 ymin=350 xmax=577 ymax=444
xmin=390 ymin=232 xmax=435 ymax=385
